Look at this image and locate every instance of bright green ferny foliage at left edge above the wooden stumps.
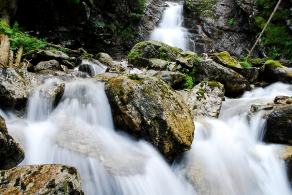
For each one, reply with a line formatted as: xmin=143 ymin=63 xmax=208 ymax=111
xmin=0 ymin=20 xmax=47 ymax=52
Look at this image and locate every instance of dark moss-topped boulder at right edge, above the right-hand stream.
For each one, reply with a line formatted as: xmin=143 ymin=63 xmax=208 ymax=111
xmin=264 ymin=60 xmax=292 ymax=83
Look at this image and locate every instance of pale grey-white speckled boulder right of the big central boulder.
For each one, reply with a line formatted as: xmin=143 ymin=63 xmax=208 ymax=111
xmin=180 ymin=81 xmax=224 ymax=118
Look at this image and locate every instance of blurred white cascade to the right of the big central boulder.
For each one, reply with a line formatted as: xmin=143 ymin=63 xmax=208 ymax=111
xmin=176 ymin=83 xmax=292 ymax=195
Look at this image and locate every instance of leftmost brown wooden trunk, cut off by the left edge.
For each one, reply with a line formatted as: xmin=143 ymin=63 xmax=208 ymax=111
xmin=0 ymin=34 xmax=10 ymax=67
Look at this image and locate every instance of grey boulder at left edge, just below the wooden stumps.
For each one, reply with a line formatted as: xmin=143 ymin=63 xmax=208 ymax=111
xmin=0 ymin=68 xmax=31 ymax=107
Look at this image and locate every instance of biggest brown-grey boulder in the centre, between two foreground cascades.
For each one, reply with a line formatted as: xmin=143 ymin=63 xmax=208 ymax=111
xmin=106 ymin=75 xmax=194 ymax=160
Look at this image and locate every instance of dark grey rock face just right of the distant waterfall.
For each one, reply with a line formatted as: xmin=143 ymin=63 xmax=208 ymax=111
xmin=184 ymin=0 xmax=255 ymax=57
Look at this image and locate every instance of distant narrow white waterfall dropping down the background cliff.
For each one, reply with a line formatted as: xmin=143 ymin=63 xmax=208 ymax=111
xmin=150 ymin=2 xmax=188 ymax=50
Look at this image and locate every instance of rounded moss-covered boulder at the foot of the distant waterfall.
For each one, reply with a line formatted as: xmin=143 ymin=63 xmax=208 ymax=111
xmin=128 ymin=41 xmax=182 ymax=67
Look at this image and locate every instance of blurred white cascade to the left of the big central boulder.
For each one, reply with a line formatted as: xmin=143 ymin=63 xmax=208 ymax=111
xmin=6 ymin=80 xmax=195 ymax=195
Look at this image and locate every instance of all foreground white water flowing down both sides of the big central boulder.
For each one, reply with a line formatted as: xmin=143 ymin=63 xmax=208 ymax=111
xmin=0 ymin=79 xmax=292 ymax=195
